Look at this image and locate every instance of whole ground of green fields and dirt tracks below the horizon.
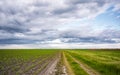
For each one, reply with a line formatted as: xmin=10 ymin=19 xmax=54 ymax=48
xmin=0 ymin=49 xmax=120 ymax=75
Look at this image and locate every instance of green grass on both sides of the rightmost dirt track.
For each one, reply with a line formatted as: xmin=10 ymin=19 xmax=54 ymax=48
xmin=64 ymin=50 xmax=120 ymax=75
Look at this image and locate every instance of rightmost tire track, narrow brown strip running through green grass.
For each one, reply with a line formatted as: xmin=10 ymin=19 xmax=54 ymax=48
xmin=68 ymin=54 xmax=100 ymax=75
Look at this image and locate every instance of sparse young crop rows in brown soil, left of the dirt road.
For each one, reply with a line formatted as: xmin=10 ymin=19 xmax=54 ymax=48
xmin=0 ymin=50 xmax=58 ymax=75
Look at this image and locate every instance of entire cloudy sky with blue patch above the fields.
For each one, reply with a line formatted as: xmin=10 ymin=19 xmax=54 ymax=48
xmin=0 ymin=0 xmax=120 ymax=49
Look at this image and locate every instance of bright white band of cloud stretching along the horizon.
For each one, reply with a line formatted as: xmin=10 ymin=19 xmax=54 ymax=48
xmin=0 ymin=43 xmax=120 ymax=49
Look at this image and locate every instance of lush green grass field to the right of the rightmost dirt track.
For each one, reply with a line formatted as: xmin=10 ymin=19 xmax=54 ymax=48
xmin=67 ymin=50 xmax=120 ymax=75
